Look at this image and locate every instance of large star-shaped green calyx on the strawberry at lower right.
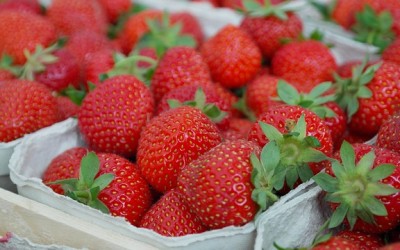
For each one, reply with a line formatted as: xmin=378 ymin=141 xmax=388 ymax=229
xmin=313 ymin=141 xmax=400 ymax=229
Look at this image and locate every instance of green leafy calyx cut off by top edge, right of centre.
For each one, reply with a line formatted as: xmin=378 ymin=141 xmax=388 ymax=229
xmin=243 ymin=0 xmax=300 ymax=20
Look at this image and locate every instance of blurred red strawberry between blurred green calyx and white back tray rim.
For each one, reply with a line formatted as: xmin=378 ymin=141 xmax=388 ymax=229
xmin=171 ymin=11 xmax=205 ymax=47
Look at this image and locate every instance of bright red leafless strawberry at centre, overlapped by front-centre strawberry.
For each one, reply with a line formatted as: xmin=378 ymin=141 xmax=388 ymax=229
xmin=136 ymin=106 xmax=222 ymax=193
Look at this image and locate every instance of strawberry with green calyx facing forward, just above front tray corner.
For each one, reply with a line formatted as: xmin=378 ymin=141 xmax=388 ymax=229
xmin=248 ymin=105 xmax=333 ymax=190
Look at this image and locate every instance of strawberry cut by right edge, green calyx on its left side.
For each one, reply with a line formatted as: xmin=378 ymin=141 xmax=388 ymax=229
xmin=335 ymin=61 xmax=400 ymax=137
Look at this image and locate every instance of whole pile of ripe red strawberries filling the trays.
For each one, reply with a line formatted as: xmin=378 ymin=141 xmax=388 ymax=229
xmin=0 ymin=0 xmax=400 ymax=249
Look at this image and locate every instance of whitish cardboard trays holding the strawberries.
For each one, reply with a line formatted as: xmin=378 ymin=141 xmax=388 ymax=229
xmin=0 ymin=0 xmax=382 ymax=250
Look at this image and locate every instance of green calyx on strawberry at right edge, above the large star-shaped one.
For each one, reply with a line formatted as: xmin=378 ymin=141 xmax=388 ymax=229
xmin=334 ymin=59 xmax=382 ymax=121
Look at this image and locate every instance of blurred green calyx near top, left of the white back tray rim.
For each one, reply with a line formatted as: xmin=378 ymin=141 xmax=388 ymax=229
xmin=135 ymin=12 xmax=197 ymax=58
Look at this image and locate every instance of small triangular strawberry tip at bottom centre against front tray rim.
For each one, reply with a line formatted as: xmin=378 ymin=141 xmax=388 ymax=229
xmin=139 ymin=189 xmax=207 ymax=237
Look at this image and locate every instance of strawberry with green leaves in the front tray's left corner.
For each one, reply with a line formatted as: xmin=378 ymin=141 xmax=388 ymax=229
xmin=44 ymin=151 xmax=152 ymax=226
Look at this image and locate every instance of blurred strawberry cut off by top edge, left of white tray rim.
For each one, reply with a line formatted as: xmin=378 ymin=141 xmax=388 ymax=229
xmin=98 ymin=0 xmax=133 ymax=23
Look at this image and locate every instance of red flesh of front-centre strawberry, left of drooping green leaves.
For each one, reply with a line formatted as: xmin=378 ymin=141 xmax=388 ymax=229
xmin=178 ymin=140 xmax=260 ymax=229
